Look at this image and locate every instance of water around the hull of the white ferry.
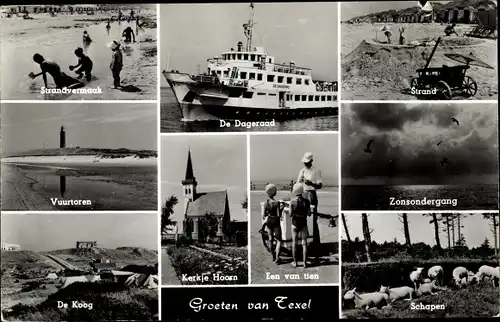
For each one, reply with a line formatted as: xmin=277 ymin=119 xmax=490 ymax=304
xmin=161 ymin=87 xmax=339 ymax=133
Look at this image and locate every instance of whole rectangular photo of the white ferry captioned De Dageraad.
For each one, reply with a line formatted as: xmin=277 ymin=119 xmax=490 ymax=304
xmin=160 ymin=2 xmax=339 ymax=133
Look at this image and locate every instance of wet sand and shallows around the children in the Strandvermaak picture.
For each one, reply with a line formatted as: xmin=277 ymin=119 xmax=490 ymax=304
xmin=0 ymin=10 xmax=157 ymax=100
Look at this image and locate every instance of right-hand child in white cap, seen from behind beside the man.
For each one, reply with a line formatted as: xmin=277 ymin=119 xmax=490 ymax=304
xmin=290 ymin=183 xmax=311 ymax=267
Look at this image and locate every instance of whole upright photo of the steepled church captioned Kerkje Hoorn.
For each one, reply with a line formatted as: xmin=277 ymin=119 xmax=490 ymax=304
xmin=160 ymin=135 xmax=248 ymax=286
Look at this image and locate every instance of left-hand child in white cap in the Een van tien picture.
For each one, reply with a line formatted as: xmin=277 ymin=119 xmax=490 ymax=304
xmin=263 ymin=183 xmax=281 ymax=264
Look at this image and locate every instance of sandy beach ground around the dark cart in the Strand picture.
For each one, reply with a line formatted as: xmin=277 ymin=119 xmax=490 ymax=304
xmin=341 ymin=23 xmax=498 ymax=100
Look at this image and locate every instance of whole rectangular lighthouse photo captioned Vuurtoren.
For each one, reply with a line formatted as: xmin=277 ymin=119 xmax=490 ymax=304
xmin=1 ymin=103 xmax=158 ymax=211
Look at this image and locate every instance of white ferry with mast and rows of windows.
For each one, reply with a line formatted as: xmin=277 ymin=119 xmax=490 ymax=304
xmin=163 ymin=3 xmax=338 ymax=121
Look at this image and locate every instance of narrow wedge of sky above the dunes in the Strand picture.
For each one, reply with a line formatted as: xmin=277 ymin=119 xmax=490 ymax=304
xmin=340 ymin=0 xmax=449 ymax=21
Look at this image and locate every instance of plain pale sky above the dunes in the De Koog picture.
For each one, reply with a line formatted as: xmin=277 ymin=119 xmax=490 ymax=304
xmin=2 ymin=214 xmax=158 ymax=251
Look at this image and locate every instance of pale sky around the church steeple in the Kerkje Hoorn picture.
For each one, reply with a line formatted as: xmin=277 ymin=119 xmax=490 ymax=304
xmin=161 ymin=135 xmax=248 ymax=231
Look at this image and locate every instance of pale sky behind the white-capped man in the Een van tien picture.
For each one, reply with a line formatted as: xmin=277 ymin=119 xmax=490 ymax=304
xmin=250 ymin=133 xmax=338 ymax=182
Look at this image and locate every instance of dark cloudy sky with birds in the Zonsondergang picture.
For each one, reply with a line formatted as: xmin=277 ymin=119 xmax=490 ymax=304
xmin=341 ymin=103 xmax=498 ymax=185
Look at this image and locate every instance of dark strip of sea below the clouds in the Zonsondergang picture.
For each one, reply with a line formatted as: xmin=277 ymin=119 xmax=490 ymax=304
xmin=342 ymin=184 xmax=499 ymax=210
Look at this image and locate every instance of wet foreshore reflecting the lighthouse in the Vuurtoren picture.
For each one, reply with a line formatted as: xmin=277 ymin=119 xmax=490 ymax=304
xmin=2 ymin=163 xmax=158 ymax=211
